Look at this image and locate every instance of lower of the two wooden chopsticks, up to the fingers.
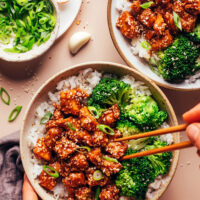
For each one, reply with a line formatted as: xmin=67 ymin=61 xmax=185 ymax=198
xmin=121 ymin=141 xmax=193 ymax=160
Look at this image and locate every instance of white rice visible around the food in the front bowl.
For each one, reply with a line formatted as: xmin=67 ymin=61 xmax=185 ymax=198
xmin=28 ymin=68 xmax=173 ymax=200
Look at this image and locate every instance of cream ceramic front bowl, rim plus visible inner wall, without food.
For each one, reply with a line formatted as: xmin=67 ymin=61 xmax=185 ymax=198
xmin=20 ymin=62 xmax=179 ymax=200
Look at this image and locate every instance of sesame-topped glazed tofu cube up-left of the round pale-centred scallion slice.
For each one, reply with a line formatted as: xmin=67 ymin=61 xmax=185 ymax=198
xmin=70 ymin=153 xmax=89 ymax=171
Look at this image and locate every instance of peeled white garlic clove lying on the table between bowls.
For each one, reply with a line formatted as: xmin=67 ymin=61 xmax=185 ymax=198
xmin=69 ymin=31 xmax=91 ymax=54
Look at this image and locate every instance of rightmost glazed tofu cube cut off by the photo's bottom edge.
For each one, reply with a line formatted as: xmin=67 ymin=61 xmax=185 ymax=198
xmin=99 ymin=185 xmax=119 ymax=200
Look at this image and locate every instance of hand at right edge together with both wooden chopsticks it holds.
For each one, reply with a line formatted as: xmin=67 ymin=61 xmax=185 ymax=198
xmin=118 ymin=104 xmax=200 ymax=160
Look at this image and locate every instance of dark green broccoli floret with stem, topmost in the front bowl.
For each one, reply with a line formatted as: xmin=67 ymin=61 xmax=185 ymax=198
xmin=88 ymin=78 xmax=130 ymax=108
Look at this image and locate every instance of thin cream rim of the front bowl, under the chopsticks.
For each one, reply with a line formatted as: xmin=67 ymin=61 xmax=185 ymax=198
xmin=20 ymin=61 xmax=180 ymax=200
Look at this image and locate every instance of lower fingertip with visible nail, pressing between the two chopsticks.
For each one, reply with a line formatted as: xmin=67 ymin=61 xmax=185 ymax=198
xmin=186 ymin=123 xmax=200 ymax=150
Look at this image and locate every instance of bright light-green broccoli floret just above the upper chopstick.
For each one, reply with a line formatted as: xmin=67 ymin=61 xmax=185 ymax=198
xmin=125 ymin=96 xmax=167 ymax=130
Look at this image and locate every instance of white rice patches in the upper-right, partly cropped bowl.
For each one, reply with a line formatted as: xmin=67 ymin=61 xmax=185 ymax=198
xmin=116 ymin=0 xmax=200 ymax=84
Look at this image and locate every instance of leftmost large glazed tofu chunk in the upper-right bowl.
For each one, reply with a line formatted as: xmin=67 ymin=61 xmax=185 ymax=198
xmin=116 ymin=11 xmax=140 ymax=39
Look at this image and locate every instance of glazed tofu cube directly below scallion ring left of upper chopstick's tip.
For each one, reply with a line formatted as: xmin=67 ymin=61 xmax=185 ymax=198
xmin=92 ymin=130 xmax=108 ymax=147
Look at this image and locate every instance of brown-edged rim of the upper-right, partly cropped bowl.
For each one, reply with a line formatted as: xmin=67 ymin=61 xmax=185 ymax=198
xmin=107 ymin=0 xmax=200 ymax=92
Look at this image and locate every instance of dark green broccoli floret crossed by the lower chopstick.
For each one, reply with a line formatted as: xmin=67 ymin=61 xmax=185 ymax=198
xmin=115 ymin=140 xmax=172 ymax=200
